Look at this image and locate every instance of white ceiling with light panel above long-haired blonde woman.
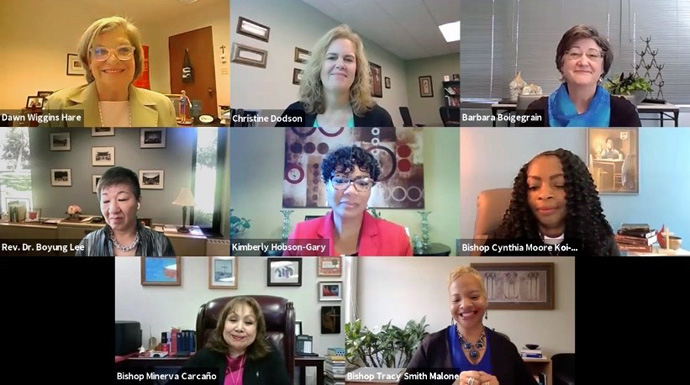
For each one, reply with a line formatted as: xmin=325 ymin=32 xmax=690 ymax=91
xmin=302 ymin=0 xmax=460 ymax=60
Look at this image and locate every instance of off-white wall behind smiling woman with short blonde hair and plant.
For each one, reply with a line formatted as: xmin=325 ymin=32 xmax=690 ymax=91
xmin=357 ymin=257 xmax=575 ymax=356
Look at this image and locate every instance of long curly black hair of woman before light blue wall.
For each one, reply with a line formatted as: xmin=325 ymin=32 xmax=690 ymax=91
xmin=496 ymin=148 xmax=613 ymax=256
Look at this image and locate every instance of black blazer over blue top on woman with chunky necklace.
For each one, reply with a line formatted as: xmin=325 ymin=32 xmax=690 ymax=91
xmin=398 ymin=328 xmax=538 ymax=385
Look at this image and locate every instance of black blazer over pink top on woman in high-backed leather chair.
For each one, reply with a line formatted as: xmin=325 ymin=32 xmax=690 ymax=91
xmin=168 ymin=347 xmax=292 ymax=385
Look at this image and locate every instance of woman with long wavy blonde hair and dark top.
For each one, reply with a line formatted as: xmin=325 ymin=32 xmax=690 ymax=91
xmin=279 ymin=24 xmax=393 ymax=127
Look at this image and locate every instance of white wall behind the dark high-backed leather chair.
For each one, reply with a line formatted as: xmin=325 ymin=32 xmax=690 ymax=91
xmin=115 ymin=257 xmax=345 ymax=355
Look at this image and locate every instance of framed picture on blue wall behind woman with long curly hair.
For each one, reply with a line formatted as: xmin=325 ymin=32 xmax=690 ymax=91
xmin=586 ymin=127 xmax=640 ymax=195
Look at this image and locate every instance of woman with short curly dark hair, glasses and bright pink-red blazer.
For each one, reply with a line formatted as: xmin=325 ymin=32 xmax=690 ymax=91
xmin=285 ymin=146 xmax=412 ymax=256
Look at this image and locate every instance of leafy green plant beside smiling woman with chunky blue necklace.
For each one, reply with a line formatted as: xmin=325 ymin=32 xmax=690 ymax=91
xmin=345 ymin=317 xmax=429 ymax=368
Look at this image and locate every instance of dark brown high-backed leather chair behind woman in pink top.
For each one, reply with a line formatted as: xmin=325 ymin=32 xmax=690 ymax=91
xmin=196 ymin=295 xmax=295 ymax=378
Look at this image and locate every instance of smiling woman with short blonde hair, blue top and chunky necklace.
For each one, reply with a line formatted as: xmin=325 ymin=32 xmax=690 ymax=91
xmin=399 ymin=266 xmax=537 ymax=385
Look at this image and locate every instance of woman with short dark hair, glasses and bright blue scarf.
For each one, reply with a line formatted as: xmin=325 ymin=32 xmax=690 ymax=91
xmin=525 ymin=24 xmax=641 ymax=127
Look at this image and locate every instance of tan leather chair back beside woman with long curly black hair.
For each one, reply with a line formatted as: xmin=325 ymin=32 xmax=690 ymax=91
xmin=473 ymin=188 xmax=513 ymax=255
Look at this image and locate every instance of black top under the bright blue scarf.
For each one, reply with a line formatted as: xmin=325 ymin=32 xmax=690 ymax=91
xmin=520 ymin=95 xmax=642 ymax=127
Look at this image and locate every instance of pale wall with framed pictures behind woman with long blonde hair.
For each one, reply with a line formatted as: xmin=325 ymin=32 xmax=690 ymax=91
xmin=230 ymin=0 xmax=407 ymax=126
